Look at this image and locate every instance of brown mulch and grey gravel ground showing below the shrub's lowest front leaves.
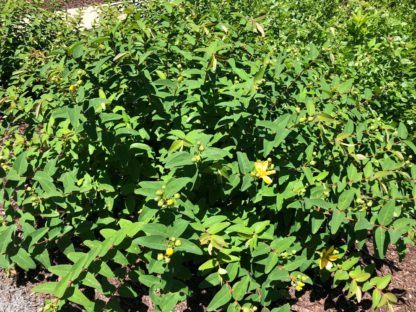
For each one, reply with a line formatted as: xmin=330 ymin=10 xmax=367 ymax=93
xmin=0 ymin=245 xmax=416 ymax=312
